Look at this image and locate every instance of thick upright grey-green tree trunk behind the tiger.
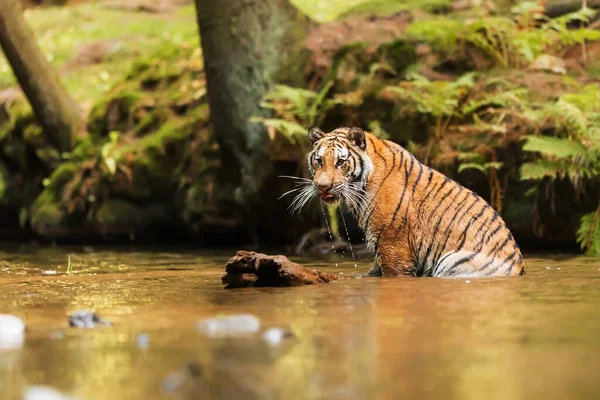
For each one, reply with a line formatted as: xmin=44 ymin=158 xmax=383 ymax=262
xmin=196 ymin=0 xmax=311 ymax=206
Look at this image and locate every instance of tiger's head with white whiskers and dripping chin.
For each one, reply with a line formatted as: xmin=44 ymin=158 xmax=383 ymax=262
xmin=284 ymin=128 xmax=373 ymax=216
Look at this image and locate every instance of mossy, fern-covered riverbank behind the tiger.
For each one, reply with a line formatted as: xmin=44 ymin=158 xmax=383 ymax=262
xmin=0 ymin=1 xmax=600 ymax=253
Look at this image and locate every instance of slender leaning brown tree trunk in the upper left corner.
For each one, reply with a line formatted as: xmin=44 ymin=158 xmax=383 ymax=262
xmin=0 ymin=0 xmax=84 ymax=152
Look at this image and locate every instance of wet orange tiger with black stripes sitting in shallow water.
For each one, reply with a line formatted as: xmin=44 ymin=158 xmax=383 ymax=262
xmin=291 ymin=127 xmax=525 ymax=277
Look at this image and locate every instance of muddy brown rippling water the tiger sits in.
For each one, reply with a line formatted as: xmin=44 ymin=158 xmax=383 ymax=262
xmin=0 ymin=248 xmax=600 ymax=400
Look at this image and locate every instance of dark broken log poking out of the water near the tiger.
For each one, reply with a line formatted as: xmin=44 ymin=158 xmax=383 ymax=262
xmin=221 ymin=250 xmax=338 ymax=289
